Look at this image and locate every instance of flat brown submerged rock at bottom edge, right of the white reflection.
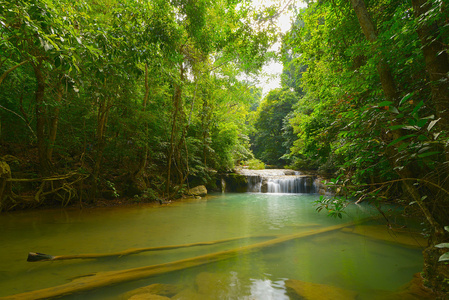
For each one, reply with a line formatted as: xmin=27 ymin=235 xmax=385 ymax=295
xmin=285 ymin=279 xmax=357 ymax=300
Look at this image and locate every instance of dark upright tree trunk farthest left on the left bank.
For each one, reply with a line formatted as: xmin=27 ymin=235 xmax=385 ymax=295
xmin=32 ymin=63 xmax=51 ymax=176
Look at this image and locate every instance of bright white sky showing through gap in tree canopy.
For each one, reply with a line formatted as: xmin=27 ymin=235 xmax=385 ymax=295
xmin=253 ymin=0 xmax=307 ymax=96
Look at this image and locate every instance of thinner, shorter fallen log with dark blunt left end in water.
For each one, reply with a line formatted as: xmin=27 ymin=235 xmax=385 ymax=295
xmin=27 ymin=234 xmax=279 ymax=262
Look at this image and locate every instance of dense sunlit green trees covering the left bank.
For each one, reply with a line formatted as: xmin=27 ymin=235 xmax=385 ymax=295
xmin=0 ymin=0 xmax=276 ymax=206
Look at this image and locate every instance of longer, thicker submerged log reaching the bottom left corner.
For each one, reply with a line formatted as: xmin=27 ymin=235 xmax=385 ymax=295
xmin=0 ymin=218 xmax=373 ymax=300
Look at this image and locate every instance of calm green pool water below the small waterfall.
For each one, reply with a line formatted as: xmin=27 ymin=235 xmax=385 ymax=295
xmin=0 ymin=193 xmax=422 ymax=300
